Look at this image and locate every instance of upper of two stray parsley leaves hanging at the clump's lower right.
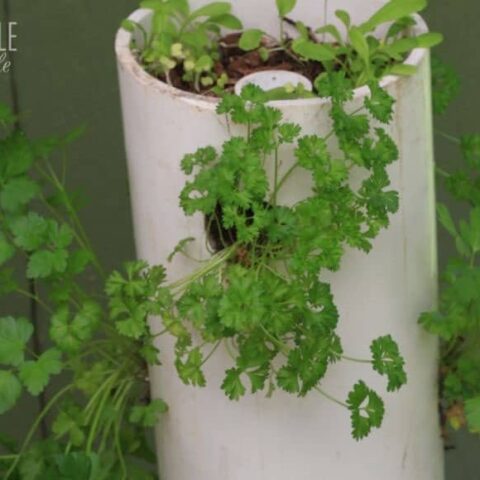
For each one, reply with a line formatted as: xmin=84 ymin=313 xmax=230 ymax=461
xmin=370 ymin=335 xmax=407 ymax=392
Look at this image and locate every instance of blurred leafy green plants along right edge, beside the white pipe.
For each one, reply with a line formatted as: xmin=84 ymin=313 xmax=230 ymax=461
xmin=420 ymin=130 xmax=480 ymax=433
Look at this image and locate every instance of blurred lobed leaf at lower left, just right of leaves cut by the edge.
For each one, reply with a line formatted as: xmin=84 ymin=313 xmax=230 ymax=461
xmin=19 ymin=348 xmax=63 ymax=396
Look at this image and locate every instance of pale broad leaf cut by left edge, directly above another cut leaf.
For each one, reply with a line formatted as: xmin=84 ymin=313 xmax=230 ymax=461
xmin=0 ymin=317 xmax=33 ymax=366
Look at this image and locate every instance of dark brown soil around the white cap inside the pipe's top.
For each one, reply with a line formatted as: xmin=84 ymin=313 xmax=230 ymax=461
xmin=161 ymin=33 xmax=323 ymax=96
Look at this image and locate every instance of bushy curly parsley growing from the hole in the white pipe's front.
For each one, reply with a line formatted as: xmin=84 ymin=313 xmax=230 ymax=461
xmin=156 ymin=80 xmax=406 ymax=439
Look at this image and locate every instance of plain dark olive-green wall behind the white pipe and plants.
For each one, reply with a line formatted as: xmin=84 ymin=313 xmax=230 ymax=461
xmin=0 ymin=0 xmax=480 ymax=474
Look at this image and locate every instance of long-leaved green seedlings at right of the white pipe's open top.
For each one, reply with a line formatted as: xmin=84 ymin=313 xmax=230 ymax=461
xmin=240 ymin=0 xmax=442 ymax=86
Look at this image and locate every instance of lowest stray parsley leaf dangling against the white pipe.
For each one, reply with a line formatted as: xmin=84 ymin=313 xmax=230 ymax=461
xmin=347 ymin=380 xmax=385 ymax=440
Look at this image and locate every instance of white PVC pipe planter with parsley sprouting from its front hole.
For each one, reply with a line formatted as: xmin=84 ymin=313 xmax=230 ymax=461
xmin=116 ymin=0 xmax=443 ymax=480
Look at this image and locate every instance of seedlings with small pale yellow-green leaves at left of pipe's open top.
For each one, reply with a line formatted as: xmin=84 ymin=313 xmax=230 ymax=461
xmin=122 ymin=0 xmax=242 ymax=91
